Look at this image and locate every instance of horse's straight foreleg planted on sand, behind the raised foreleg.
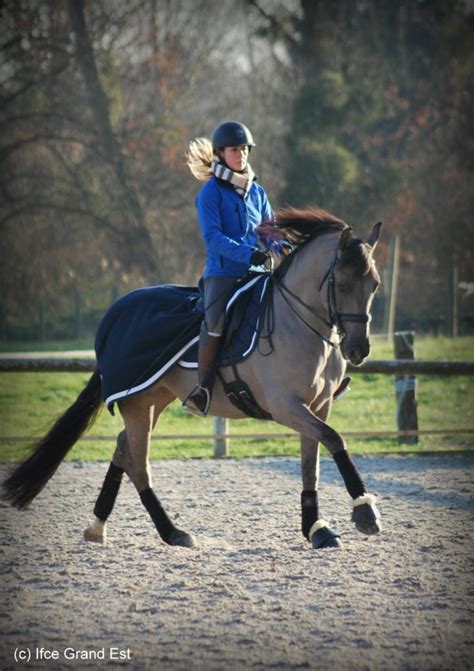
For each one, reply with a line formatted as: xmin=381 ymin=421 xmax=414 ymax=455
xmin=301 ymin=404 xmax=342 ymax=550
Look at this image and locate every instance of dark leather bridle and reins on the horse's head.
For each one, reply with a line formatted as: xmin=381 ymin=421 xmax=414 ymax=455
xmin=272 ymin=250 xmax=372 ymax=349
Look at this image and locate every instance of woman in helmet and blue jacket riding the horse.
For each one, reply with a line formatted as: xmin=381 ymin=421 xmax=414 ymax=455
xmin=184 ymin=121 xmax=273 ymax=416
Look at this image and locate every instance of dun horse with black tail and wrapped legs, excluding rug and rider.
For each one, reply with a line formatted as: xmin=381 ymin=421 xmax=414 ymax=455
xmin=2 ymin=208 xmax=381 ymax=550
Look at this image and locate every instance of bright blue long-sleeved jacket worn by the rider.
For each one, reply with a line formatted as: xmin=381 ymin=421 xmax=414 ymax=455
xmin=196 ymin=176 xmax=273 ymax=277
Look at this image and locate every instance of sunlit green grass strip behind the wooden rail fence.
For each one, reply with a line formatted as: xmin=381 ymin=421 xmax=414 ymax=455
xmin=0 ymin=337 xmax=474 ymax=461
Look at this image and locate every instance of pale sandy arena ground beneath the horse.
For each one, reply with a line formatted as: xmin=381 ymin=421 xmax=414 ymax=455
xmin=0 ymin=453 xmax=474 ymax=671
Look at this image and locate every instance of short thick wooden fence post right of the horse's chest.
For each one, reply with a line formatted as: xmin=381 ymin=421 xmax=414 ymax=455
xmin=393 ymin=331 xmax=418 ymax=443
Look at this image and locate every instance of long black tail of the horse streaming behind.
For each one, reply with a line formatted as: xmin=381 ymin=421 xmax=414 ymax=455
xmin=2 ymin=370 xmax=102 ymax=510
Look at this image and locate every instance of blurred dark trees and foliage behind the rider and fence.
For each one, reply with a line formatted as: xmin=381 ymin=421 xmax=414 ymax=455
xmin=0 ymin=0 xmax=474 ymax=336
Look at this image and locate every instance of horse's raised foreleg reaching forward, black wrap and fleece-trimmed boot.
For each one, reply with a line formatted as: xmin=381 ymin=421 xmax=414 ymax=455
xmin=270 ymin=397 xmax=381 ymax=534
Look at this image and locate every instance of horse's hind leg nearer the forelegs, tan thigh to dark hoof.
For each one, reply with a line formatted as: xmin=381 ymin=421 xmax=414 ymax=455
xmin=120 ymin=389 xmax=194 ymax=547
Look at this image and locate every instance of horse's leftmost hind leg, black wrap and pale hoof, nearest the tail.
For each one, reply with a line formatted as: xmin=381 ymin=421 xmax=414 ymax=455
xmin=84 ymin=431 xmax=128 ymax=543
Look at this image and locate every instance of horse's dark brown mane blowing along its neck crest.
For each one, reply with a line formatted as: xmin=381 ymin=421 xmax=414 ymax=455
xmin=262 ymin=207 xmax=348 ymax=278
